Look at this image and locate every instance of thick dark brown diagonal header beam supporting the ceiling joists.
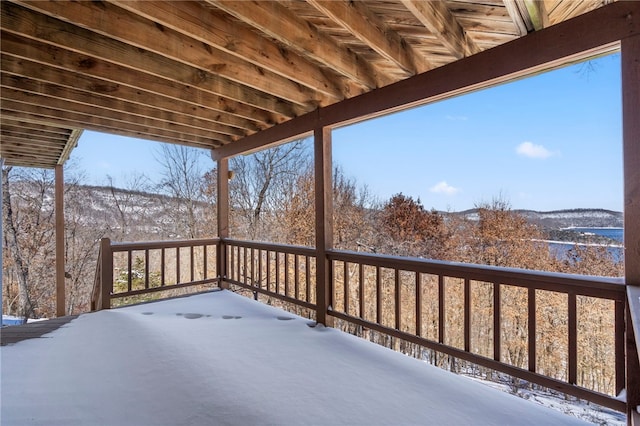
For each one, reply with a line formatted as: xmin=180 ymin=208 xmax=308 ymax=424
xmin=215 ymin=2 xmax=640 ymax=158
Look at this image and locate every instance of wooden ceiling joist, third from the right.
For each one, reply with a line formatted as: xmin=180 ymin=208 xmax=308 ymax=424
xmin=307 ymin=0 xmax=433 ymax=75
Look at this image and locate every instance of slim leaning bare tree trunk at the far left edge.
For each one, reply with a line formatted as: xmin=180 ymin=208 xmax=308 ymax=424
xmin=2 ymin=167 xmax=34 ymax=320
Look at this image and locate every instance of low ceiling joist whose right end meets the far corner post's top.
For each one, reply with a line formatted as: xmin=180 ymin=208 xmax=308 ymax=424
xmin=0 ymin=98 xmax=224 ymax=148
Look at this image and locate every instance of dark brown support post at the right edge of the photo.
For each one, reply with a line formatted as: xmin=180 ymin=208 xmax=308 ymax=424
xmin=621 ymin=36 xmax=640 ymax=424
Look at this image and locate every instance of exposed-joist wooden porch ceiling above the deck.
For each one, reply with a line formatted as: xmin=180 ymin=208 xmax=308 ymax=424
xmin=0 ymin=0 xmax=624 ymax=167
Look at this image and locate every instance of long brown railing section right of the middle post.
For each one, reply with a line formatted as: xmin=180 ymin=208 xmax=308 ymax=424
xmin=328 ymin=250 xmax=626 ymax=411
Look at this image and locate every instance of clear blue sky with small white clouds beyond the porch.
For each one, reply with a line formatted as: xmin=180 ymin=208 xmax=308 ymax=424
xmin=72 ymin=54 xmax=623 ymax=211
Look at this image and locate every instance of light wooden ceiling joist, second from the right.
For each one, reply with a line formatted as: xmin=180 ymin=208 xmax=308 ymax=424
xmin=402 ymin=0 xmax=480 ymax=59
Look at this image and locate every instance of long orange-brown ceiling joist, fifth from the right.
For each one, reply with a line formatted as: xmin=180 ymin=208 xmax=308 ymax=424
xmin=108 ymin=0 xmax=345 ymax=105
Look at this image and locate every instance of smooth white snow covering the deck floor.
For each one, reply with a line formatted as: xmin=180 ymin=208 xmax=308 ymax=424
xmin=0 ymin=291 xmax=583 ymax=426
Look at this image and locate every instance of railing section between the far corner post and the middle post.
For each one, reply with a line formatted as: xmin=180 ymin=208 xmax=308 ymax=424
xmin=224 ymin=239 xmax=316 ymax=309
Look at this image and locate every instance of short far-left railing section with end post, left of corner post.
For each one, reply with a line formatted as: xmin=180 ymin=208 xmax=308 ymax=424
xmin=91 ymin=238 xmax=220 ymax=310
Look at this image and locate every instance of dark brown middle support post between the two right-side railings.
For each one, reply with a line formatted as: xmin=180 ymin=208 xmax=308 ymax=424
xmin=313 ymin=127 xmax=333 ymax=327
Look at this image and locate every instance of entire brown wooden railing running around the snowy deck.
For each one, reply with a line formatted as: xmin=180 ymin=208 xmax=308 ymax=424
xmin=92 ymin=239 xmax=627 ymax=412
